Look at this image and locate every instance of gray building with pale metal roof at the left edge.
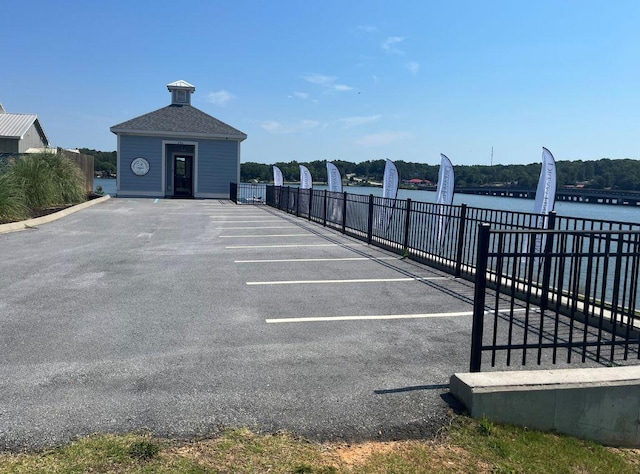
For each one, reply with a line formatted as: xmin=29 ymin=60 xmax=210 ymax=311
xmin=0 ymin=104 xmax=49 ymax=153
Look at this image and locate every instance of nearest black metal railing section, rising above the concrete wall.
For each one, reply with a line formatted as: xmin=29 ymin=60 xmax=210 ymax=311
xmin=470 ymin=228 xmax=640 ymax=372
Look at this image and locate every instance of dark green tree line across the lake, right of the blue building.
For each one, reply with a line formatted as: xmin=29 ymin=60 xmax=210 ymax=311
xmin=240 ymin=158 xmax=640 ymax=191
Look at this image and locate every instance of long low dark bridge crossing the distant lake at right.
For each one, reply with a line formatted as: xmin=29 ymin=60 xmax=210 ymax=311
xmin=452 ymin=186 xmax=640 ymax=206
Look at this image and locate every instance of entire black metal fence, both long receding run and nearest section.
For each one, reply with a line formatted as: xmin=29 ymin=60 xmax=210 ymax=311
xmin=237 ymin=185 xmax=640 ymax=371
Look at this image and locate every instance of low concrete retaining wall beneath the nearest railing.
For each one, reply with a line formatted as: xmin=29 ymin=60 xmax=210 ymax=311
xmin=450 ymin=366 xmax=640 ymax=447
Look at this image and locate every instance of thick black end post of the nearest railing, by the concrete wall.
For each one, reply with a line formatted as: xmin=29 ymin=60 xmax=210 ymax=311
xmin=470 ymin=223 xmax=491 ymax=372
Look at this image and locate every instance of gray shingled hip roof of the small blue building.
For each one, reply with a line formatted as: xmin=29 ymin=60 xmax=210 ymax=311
xmin=110 ymin=105 xmax=247 ymax=141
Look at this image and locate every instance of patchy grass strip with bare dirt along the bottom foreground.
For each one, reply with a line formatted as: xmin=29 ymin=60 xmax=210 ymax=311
xmin=0 ymin=417 xmax=640 ymax=474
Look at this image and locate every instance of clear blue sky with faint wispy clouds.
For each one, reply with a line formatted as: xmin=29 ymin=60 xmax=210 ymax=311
xmin=0 ymin=0 xmax=640 ymax=165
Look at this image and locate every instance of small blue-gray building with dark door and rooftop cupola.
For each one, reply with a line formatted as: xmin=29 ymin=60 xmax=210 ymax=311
xmin=110 ymin=81 xmax=247 ymax=199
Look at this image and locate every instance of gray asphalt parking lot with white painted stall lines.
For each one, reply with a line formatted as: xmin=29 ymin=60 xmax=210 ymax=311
xmin=0 ymin=199 xmax=473 ymax=449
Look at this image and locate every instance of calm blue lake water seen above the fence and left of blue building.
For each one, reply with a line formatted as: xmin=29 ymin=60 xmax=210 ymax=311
xmin=94 ymin=178 xmax=640 ymax=223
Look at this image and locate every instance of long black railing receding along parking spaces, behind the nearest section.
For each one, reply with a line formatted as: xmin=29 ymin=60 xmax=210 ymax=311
xmin=255 ymin=185 xmax=640 ymax=280
